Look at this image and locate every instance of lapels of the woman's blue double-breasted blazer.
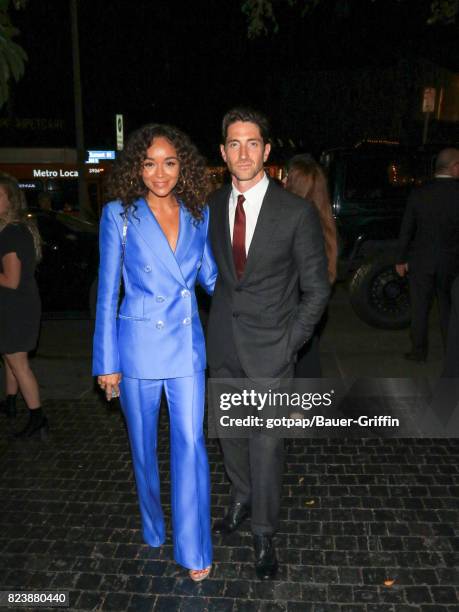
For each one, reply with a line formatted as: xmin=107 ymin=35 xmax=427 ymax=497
xmin=128 ymin=198 xmax=188 ymax=285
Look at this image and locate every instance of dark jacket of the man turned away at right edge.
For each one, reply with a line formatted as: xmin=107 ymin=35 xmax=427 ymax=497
xmin=397 ymin=178 xmax=459 ymax=272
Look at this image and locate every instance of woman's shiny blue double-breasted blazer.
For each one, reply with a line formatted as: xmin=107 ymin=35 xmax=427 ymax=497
xmin=93 ymin=198 xmax=217 ymax=379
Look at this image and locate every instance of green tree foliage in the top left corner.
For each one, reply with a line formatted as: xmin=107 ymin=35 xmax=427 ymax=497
xmin=0 ymin=0 xmax=27 ymax=108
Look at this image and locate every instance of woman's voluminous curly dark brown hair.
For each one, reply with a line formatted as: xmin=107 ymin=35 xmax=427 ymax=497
xmin=108 ymin=123 xmax=209 ymax=220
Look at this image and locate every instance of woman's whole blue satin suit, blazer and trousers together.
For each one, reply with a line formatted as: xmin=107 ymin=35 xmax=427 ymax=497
xmin=93 ymin=198 xmax=217 ymax=569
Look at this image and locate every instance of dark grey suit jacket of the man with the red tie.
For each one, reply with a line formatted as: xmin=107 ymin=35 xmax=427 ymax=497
xmin=207 ymin=181 xmax=330 ymax=378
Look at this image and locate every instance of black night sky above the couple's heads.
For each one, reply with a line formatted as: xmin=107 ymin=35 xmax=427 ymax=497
xmin=0 ymin=0 xmax=459 ymax=157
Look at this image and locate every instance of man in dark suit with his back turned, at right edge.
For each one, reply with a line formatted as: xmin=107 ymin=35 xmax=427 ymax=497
xmin=396 ymin=148 xmax=459 ymax=362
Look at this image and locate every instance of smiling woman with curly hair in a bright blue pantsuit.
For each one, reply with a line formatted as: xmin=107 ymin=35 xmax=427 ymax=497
xmin=93 ymin=124 xmax=217 ymax=581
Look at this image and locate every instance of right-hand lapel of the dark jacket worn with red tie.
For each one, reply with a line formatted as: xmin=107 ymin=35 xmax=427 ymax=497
xmin=241 ymin=181 xmax=279 ymax=281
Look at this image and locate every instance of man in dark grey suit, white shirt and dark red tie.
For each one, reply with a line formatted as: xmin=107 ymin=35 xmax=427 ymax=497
xmin=207 ymin=108 xmax=330 ymax=579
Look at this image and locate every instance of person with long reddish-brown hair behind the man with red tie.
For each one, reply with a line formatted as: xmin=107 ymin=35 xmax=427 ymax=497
xmin=283 ymin=154 xmax=338 ymax=378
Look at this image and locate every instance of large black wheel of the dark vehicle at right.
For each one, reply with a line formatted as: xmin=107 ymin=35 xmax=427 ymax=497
xmin=349 ymin=257 xmax=410 ymax=329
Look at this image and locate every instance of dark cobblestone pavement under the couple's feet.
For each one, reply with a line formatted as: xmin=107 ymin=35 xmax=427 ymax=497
xmin=0 ymin=400 xmax=459 ymax=612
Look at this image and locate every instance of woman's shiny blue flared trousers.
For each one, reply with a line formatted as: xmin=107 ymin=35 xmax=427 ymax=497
xmin=121 ymin=372 xmax=212 ymax=569
